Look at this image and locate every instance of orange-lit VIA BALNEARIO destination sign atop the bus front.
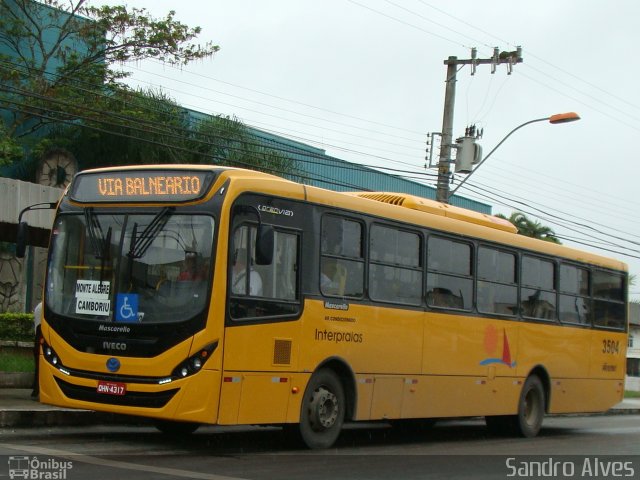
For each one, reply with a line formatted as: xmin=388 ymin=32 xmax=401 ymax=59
xmin=70 ymin=170 xmax=214 ymax=203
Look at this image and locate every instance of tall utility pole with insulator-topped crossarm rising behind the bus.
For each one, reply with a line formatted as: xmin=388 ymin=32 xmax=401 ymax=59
xmin=436 ymin=47 xmax=522 ymax=203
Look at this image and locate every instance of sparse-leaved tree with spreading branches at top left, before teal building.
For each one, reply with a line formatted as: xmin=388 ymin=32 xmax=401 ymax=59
xmin=0 ymin=0 xmax=219 ymax=137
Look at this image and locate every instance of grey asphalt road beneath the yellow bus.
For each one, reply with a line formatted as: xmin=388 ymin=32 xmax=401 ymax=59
xmin=0 ymin=415 xmax=640 ymax=480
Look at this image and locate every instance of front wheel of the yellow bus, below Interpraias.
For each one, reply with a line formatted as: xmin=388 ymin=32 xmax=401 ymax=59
xmin=300 ymin=368 xmax=346 ymax=449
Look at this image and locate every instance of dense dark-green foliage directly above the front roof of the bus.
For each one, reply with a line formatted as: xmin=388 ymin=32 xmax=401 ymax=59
xmin=33 ymin=88 xmax=296 ymax=175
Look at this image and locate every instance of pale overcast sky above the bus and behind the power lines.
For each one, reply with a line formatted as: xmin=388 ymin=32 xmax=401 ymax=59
xmin=92 ymin=0 xmax=640 ymax=299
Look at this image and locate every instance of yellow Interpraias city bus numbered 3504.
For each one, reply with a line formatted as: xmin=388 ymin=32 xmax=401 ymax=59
xmin=18 ymin=165 xmax=628 ymax=448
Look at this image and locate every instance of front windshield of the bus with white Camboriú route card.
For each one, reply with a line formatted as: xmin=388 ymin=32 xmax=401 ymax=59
xmin=46 ymin=208 xmax=214 ymax=324
